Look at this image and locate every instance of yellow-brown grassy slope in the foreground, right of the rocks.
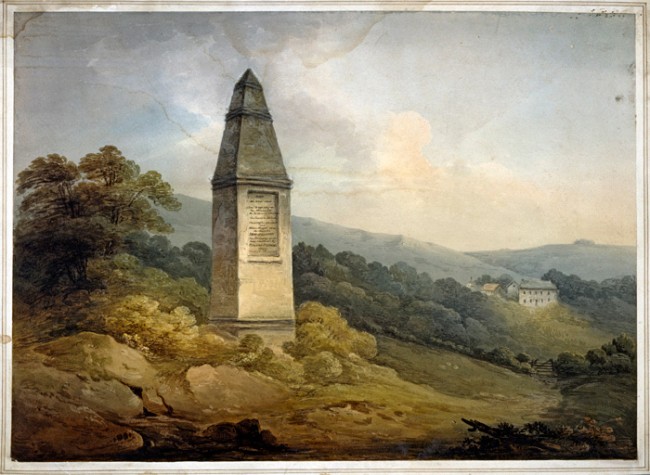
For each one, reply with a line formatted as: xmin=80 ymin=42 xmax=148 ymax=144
xmin=251 ymin=338 xmax=561 ymax=453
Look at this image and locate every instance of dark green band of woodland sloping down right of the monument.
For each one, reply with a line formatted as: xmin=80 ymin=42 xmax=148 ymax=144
xmin=293 ymin=243 xmax=506 ymax=352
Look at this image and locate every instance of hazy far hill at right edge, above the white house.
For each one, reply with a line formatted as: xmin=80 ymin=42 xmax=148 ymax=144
xmin=467 ymin=240 xmax=636 ymax=282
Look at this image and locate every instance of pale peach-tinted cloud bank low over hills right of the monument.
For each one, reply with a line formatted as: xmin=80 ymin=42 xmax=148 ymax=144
xmin=297 ymin=111 xmax=635 ymax=250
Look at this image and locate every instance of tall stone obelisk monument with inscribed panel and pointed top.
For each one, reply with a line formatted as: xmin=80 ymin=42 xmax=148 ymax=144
xmin=209 ymin=69 xmax=295 ymax=339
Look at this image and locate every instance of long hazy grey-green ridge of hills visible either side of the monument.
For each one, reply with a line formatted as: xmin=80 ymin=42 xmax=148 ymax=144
xmin=161 ymin=195 xmax=636 ymax=283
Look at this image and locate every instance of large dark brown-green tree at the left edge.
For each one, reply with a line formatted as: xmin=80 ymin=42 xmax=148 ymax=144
xmin=15 ymin=145 xmax=180 ymax=296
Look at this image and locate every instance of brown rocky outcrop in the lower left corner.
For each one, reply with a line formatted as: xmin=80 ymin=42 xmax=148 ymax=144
xmin=12 ymin=332 xmax=287 ymax=461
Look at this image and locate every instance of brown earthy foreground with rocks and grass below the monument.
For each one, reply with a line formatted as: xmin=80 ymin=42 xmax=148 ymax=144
xmin=12 ymin=332 xmax=632 ymax=461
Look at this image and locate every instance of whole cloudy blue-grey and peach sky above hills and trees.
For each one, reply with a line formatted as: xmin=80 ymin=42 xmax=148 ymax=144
xmin=14 ymin=12 xmax=636 ymax=251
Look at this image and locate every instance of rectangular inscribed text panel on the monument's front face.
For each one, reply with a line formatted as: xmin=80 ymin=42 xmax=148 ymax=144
xmin=246 ymin=192 xmax=280 ymax=258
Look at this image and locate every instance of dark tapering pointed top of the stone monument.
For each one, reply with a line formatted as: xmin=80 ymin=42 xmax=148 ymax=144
xmin=212 ymin=69 xmax=291 ymax=188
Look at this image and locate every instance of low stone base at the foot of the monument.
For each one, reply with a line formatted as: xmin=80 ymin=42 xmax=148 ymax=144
xmin=208 ymin=319 xmax=296 ymax=348
